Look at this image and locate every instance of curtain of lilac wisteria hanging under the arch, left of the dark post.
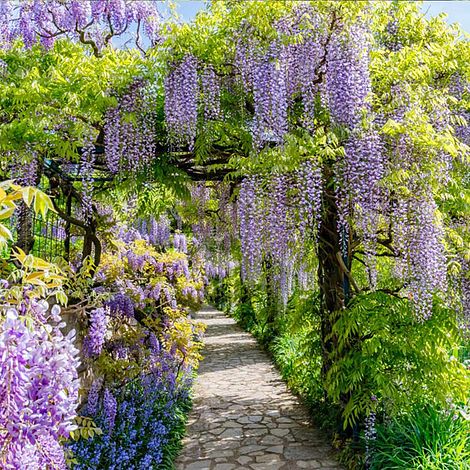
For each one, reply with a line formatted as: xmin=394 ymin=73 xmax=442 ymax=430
xmin=238 ymin=173 xmax=321 ymax=305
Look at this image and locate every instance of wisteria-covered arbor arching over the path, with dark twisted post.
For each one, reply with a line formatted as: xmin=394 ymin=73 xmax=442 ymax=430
xmin=0 ymin=1 xmax=470 ymax=426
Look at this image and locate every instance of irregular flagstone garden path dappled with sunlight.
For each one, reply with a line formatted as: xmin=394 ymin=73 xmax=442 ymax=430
xmin=176 ymin=307 xmax=342 ymax=470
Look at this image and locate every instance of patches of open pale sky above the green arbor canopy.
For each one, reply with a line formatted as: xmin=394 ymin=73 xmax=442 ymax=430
xmin=176 ymin=0 xmax=470 ymax=33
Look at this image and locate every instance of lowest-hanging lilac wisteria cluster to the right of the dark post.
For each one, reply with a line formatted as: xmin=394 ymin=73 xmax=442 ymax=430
xmin=389 ymin=93 xmax=447 ymax=319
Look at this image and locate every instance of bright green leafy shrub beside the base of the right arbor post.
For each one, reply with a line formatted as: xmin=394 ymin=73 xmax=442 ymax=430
xmin=326 ymin=292 xmax=469 ymax=427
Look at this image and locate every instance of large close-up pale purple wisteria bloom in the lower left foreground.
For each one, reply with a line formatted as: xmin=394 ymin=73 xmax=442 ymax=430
xmin=0 ymin=297 xmax=79 ymax=469
